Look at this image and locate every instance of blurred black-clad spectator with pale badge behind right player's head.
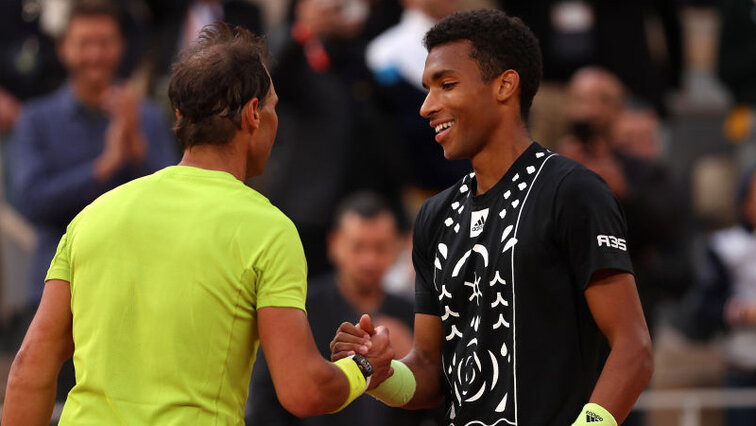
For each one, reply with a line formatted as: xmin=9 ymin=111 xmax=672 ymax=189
xmin=499 ymin=0 xmax=683 ymax=146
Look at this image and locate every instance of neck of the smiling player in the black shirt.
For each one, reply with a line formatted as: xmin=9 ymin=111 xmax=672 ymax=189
xmin=471 ymin=111 xmax=532 ymax=195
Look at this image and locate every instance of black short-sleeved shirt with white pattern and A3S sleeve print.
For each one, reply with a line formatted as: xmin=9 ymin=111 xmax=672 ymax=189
xmin=413 ymin=143 xmax=632 ymax=426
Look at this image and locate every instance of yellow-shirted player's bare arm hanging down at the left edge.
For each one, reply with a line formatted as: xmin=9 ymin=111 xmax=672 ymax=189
xmin=2 ymin=280 xmax=73 ymax=426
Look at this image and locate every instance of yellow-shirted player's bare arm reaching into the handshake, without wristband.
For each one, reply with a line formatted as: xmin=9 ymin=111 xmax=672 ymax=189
xmin=258 ymin=307 xmax=394 ymax=417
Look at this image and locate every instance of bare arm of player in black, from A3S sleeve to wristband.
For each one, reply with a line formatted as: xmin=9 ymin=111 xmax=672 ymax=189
xmin=585 ymin=270 xmax=654 ymax=424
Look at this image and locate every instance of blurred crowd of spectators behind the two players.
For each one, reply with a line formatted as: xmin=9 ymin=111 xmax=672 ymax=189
xmin=0 ymin=0 xmax=756 ymax=425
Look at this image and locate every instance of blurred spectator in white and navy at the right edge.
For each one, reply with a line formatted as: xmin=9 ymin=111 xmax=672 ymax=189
xmin=678 ymin=168 xmax=756 ymax=426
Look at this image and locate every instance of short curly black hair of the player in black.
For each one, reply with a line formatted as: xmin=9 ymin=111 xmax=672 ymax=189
xmin=424 ymin=9 xmax=543 ymax=122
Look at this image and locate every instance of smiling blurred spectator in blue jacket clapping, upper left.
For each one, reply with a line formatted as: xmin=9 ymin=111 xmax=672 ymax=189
xmin=10 ymin=0 xmax=176 ymax=342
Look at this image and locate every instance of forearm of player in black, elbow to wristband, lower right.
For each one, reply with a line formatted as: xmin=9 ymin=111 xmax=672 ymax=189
xmin=590 ymin=338 xmax=654 ymax=424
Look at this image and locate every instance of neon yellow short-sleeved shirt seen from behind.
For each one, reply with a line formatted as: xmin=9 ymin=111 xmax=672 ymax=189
xmin=47 ymin=166 xmax=307 ymax=426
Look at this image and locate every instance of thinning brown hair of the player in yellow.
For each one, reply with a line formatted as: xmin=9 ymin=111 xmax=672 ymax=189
xmin=168 ymin=22 xmax=271 ymax=149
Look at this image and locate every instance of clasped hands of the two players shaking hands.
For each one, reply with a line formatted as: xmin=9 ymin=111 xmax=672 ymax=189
xmin=330 ymin=314 xmax=394 ymax=390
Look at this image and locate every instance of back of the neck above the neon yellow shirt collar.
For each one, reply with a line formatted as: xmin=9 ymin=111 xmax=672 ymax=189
xmin=179 ymin=130 xmax=252 ymax=182
